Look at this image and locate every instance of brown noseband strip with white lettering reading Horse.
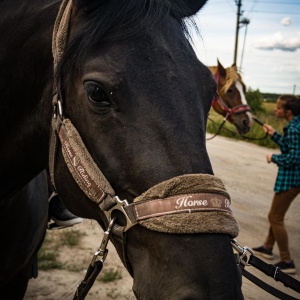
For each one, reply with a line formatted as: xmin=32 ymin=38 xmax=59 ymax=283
xmin=130 ymin=193 xmax=231 ymax=221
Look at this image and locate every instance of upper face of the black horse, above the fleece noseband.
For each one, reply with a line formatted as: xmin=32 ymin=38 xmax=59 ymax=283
xmin=52 ymin=1 xmax=216 ymax=217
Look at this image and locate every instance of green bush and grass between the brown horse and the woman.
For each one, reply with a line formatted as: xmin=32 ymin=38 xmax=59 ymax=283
xmin=206 ymin=88 xmax=287 ymax=148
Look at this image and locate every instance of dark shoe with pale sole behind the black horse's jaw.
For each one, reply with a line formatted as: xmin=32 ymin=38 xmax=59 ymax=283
xmin=49 ymin=192 xmax=83 ymax=227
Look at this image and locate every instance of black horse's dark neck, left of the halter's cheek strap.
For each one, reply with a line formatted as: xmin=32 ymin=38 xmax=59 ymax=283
xmin=0 ymin=1 xmax=59 ymax=199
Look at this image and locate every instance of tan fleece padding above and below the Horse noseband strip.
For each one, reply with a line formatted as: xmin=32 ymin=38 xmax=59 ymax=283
xmin=134 ymin=174 xmax=239 ymax=238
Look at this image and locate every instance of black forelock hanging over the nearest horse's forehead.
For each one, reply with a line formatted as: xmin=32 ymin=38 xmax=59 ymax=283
xmin=56 ymin=0 xmax=197 ymax=78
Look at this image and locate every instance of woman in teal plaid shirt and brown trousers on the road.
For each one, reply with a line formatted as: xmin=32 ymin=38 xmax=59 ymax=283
xmin=253 ymin=95 xmax=300 ymax=274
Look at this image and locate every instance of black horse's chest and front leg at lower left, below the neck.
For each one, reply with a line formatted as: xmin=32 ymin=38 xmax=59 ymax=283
xmin=0 ymin=171 xmax=48 ymax=299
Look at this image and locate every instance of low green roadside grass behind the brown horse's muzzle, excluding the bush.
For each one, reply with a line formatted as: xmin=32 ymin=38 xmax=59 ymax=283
xmin=206 ymin=103 xmax=287 ymax=148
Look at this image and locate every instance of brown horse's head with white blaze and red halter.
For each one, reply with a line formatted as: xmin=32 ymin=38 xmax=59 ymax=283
xmin=209 ymin=60 xmax=252 ymax=134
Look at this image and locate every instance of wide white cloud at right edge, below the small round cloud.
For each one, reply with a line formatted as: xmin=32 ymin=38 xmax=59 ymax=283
xmin=254 ymin=32 xmax=300 ymax=52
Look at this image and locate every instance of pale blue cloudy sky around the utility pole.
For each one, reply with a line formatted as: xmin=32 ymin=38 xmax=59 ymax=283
xmin=192 ymin=0 xmax=300 ymax=95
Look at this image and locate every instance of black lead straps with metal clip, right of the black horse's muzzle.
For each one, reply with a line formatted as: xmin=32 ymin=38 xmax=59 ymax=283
xmin=231 ymin=239 xmax=300 ymax=300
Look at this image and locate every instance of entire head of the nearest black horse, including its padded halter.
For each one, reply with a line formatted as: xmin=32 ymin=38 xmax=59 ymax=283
xmin=50 ymin=0 xmax=242 ymax=300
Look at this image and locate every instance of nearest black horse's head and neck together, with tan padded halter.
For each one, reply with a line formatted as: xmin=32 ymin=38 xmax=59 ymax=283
xmin=0 ymin=0 xmax=243 ymax=300
